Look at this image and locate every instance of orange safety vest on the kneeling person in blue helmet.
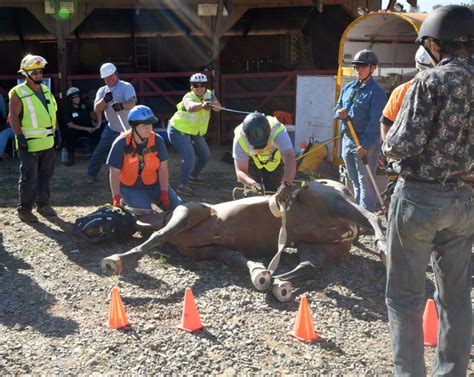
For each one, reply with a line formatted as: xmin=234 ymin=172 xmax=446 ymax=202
xmin=120 ymin=130 xmax=160 ymax=186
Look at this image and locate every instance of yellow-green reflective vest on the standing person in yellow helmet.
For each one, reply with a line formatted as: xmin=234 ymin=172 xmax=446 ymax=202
xmin=8 ymin=82 xmax=58 ymax=152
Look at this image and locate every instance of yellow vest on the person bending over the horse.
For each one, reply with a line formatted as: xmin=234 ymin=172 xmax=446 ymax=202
xmin=234 ymin=116 xmax=285 ymax=171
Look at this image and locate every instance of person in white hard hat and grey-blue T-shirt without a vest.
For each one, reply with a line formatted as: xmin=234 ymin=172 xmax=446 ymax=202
xmin=86 ymin=63 xmax=137 ymax=184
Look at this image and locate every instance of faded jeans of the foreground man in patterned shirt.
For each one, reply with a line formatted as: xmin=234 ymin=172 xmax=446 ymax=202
xmin=386 ymin=178 xmax=474 ymax=376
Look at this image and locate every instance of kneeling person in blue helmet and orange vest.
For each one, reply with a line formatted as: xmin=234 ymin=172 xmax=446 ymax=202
xmin=107 ymin=105 xmax=182 ymax=213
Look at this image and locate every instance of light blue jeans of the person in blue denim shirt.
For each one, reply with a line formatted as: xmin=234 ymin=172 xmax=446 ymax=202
xmin=342 ymin=136 xmax=380 ymax=212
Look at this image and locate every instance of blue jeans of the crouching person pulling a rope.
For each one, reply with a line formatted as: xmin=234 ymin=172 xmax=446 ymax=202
xmin=168 ymin=124 xmax=211 ymax=186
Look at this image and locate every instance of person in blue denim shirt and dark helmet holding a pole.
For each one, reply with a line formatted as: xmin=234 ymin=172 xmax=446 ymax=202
xmin=334 ymin=50 xmax=387 ymax=212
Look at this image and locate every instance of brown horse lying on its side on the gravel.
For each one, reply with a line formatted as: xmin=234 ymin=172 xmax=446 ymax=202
xmin=102 ymin=180 xmax=385 ymax=301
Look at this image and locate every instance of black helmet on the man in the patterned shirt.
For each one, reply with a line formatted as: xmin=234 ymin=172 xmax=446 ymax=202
xmin=416 ymin=5 xmax=474 ymax=44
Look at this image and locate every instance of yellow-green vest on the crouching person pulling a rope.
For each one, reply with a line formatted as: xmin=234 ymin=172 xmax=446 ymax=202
xmin=170 ymin=89 xmax=211 ymax=136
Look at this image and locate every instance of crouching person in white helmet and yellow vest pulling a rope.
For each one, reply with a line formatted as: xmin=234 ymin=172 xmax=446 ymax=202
xmin=168 ymin=73 xmax=221 ymax=195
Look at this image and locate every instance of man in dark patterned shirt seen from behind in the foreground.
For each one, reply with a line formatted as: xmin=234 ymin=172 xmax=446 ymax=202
xmin=382 ymin=5 xmax=474 ymax=376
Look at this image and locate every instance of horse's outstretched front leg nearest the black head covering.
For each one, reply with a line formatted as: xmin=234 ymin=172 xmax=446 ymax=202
xmin=101 ymin=203 xmax=212 ymax=274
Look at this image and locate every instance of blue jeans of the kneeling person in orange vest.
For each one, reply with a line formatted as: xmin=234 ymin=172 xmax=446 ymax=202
xmin=120 ymin=183 xmax=183 ymax=209
